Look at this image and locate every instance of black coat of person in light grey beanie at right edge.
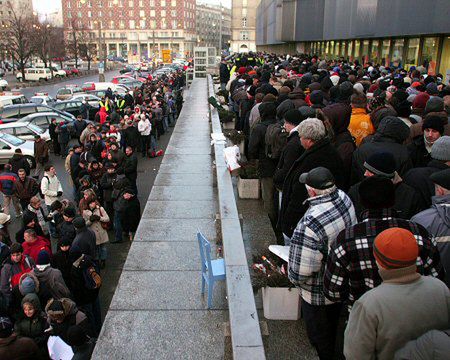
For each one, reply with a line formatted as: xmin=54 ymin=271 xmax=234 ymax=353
xmin=403 ymin=159 xmax=449 ymax=208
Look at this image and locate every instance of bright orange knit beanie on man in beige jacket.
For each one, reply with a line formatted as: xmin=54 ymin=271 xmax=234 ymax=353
xmin=373 ymin=227 xmax=419 ymax=269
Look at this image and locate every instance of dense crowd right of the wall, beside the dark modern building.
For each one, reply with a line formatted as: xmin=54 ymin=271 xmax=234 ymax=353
xmin=220 ymin=53 xmax=450 ymax=360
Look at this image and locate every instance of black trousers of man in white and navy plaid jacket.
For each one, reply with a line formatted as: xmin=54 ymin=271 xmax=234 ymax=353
xmin=302 ymin=300 xmax=342 ymax=360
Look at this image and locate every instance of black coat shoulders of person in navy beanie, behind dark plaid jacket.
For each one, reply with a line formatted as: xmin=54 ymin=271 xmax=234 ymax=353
xmin=348 ymin=181 xmax=424 ymax=221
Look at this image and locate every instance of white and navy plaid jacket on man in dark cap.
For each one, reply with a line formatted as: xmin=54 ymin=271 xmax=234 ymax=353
xmin=289 ymin=190 xmax=357 ymax=305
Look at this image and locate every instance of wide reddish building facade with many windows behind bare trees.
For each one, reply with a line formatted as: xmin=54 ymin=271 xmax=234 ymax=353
xmin=62 ymin=0 xmax=197 ymax=59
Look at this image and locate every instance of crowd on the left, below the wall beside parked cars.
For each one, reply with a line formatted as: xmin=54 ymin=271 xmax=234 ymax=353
xmin=0 ymin=71 xmax=184 ymax=359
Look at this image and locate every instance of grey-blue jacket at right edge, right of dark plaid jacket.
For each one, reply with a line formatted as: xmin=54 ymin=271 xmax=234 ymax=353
xmin=411 ymin=194 xmax=450 ymax=287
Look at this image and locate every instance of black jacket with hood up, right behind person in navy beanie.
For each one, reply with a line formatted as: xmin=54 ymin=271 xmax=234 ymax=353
xmin=351 ymin=116 xmax=412 ymax=184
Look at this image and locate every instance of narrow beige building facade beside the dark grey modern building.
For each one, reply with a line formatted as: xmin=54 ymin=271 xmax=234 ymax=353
xmin=231 ymin=0 xmax=260 ymax=52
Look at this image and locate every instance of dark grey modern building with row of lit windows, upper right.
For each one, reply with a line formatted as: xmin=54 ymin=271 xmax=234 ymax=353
xmin=256 ymin=0 xmax=450 ymax=75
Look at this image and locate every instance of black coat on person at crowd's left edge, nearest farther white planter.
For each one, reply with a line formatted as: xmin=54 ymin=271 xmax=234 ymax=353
xmin=248 ymin=119 xmax=278 ymax=179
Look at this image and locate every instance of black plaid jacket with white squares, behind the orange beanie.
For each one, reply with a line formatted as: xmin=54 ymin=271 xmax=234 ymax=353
xmin=324 ymin=209 xmax=444 ymax=311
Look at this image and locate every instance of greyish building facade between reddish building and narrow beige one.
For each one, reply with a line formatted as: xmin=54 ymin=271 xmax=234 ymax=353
xmin=196 ymin=3 xmax=231 ymax=54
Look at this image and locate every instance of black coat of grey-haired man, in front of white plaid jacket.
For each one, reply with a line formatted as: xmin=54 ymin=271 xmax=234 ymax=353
xmin=278 ymin=139 xmax=345 ymax=237
